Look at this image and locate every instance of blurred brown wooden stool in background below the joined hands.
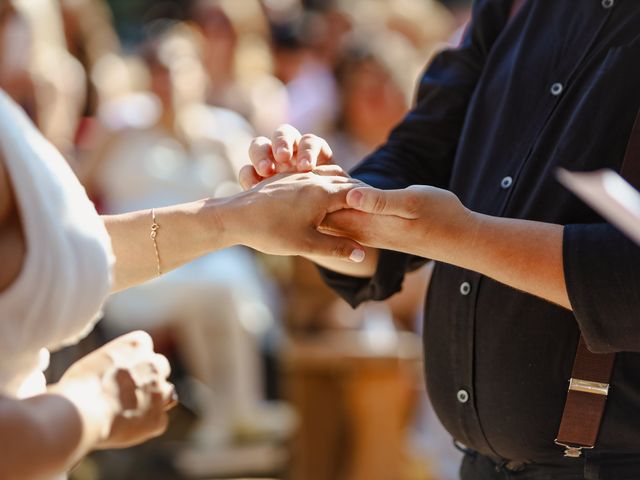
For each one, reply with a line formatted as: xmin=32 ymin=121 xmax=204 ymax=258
xmin=282 ymin=332 xmax=426 ymax=480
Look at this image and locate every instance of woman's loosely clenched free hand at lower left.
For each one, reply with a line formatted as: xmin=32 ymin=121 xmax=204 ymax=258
xmin=55 ymin=331 xmax=176 ymax=448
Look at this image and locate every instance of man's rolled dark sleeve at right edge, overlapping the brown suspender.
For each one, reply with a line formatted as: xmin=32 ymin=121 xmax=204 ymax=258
xmin=563 ymin=224 xmax=640 ymax=353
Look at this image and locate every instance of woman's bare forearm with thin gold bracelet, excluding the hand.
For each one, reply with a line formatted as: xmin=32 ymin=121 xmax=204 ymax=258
xmin=103 ymin=199 xmax=230 ymax=291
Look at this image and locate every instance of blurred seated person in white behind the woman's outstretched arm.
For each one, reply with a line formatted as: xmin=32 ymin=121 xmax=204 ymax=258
xmin=80 ymin=24 xmax=298 ymax=462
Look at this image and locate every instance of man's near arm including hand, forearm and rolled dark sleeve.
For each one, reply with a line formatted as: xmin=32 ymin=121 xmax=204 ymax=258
xmin=322 ymin=186 xmax=640 ymax=353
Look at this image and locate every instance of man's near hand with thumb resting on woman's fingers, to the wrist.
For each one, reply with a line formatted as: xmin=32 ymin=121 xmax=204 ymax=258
xmin=320 ymin=185 xmax=476 ymax=261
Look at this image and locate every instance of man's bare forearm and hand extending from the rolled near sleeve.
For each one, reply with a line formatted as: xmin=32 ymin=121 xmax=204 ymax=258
xmin=324 ymin=186 xmax=571 ymax=309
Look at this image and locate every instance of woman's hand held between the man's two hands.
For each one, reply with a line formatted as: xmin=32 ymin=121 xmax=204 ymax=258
xmin=220 ymin=172 xmax=365 ymax=263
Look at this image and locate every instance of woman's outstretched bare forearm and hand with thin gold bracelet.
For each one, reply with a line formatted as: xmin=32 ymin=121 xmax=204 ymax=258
xmin=104 ymin=172 xmax=366 ymax=290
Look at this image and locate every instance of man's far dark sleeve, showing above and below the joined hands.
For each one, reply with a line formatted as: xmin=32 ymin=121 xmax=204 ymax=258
xmin=320 ymin=0 xmax=512 ymax=306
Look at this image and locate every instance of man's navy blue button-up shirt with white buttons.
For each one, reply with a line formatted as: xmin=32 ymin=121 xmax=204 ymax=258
xmin=323 ymin=0 xmax=640 ymax=463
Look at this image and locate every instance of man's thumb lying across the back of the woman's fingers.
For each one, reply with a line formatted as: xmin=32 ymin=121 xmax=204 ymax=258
xmin=347 ymin=187 xmax=415 ymax=218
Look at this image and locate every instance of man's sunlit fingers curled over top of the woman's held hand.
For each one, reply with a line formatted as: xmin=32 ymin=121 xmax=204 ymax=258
xmin=239 ymin=125 xmax=338 ymax=190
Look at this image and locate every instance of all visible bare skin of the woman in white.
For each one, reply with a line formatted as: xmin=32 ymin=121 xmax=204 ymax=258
xmin=0 ymin=141 xmax=364 ymax=480
